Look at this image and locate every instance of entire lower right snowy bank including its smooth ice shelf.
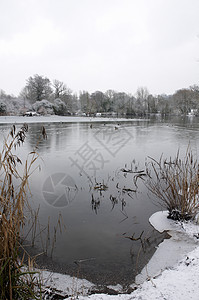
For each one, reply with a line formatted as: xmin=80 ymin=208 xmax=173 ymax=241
xmin=79 ymin=212 xmax=199 ymax=300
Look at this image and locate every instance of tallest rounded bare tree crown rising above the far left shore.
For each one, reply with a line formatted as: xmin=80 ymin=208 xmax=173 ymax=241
xmin=22 ymin=74 xmax=52 ymax=103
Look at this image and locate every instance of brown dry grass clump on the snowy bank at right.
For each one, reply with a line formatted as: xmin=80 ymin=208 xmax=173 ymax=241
xmin=146 ymin=148 xmax=199 ymax=221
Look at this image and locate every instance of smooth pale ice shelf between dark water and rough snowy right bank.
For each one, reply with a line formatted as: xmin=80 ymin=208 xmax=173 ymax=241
xmin=136 ymin=211 xmax=199 ymax=284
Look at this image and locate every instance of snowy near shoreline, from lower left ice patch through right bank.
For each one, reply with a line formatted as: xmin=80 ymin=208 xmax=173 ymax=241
xmin=39 ymin=211 xmax=199 ymax=300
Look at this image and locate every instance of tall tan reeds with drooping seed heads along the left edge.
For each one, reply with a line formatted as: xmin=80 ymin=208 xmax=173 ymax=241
xmin=0 ymin=124 xmax=45 ymax=299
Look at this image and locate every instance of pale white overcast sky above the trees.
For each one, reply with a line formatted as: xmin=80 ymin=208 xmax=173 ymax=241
xmin=0 ymin=0 xmax=199 ymax=96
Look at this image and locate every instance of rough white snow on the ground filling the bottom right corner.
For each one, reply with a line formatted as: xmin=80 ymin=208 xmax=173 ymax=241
xmin=78 ymin=247 xmax=199 ymax=300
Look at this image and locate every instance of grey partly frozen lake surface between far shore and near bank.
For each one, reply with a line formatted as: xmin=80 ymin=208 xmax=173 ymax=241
xmin=0 ymin=117 xmax=199 ymax=285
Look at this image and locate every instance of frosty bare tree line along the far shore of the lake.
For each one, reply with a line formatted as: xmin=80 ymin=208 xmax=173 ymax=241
xmin=0 ymin=74 xmax=199 ymax=116
